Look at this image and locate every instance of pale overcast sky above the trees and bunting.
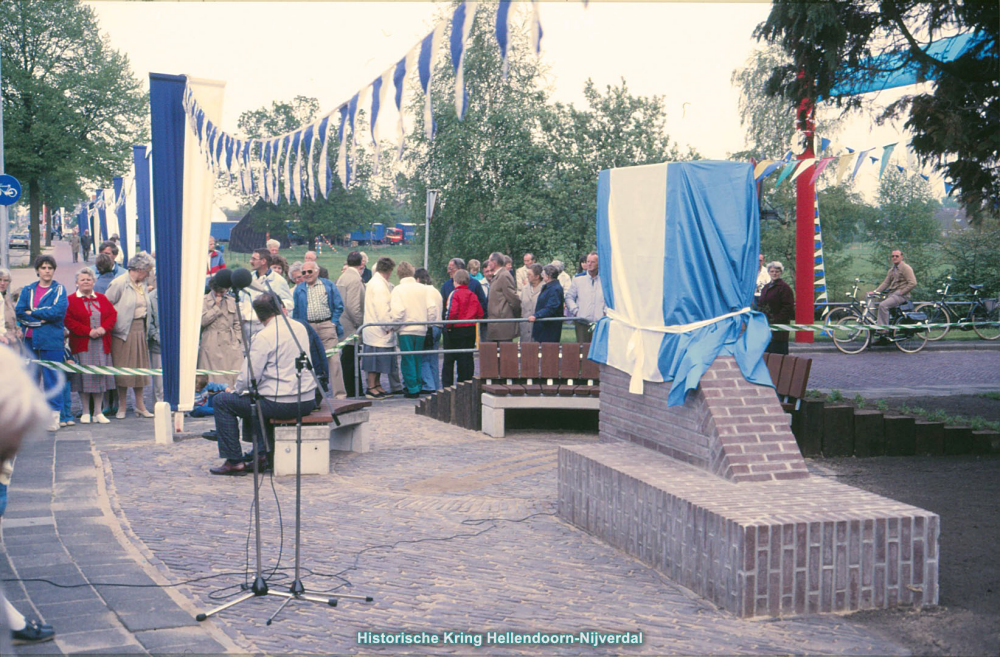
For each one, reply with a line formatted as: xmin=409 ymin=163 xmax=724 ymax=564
xmin=88 ymin=0 xmax=936 ymax=200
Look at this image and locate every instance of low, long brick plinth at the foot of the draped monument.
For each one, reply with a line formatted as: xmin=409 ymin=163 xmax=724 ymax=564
xmin=559 ymin=440 xmax=939 ymax=617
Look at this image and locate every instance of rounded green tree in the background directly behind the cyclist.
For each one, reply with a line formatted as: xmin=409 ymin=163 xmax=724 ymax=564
xmin=864 ymin=169 xmax=940 ymax=292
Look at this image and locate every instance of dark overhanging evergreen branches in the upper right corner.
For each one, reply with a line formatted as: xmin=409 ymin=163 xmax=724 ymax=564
xmin=755 ymin=0 xmax=1000 ymax=221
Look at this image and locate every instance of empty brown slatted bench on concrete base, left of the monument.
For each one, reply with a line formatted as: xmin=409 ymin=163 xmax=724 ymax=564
xmin=479 ymin=342 xmax=601 ymax=438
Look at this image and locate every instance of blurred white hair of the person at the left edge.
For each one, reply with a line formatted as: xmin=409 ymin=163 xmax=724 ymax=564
xmin=0 ymin=345 xmax=51 ymax=459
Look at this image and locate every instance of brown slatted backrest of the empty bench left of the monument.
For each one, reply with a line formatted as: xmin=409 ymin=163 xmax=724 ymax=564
xmin=479 ymin=342 xmax=601 ymax=384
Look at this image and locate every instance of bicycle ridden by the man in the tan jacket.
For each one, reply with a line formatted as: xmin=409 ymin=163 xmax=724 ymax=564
xmin=833 ymin=290 xmax=927 ymax=354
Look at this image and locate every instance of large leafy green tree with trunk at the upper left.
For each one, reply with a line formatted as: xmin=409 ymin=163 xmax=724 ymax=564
xmin=0 ymin=0 xmax=149 ymax=258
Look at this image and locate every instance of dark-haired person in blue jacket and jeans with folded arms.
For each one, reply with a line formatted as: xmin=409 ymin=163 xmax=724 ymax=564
xmin=15 ymin=255 xmax=69 ymax=431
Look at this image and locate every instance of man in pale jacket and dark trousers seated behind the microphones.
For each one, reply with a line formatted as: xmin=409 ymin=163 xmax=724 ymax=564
xmin=209 ymin=292 xmax=316 ymax=475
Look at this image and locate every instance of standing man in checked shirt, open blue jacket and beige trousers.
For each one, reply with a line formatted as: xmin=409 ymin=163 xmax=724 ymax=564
xmin=292 ymin=260 xmax=347 ymax=399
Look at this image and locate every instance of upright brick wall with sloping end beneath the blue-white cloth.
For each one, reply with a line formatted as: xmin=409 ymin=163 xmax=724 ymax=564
xmin=600 ymin=356 xmax=809 ymax=482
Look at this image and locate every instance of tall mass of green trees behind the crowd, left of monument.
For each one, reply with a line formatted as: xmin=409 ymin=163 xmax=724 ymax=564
xmin=400 ymin=6 xmax=692 ymax=273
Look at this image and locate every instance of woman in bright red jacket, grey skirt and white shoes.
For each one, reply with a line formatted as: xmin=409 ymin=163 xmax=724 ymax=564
xmin=65 ymin=269 xmax=118 ymax=424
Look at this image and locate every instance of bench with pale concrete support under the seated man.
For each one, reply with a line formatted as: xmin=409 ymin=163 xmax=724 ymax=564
xmin=269 ymin=399 xmax=372 ymax=477
